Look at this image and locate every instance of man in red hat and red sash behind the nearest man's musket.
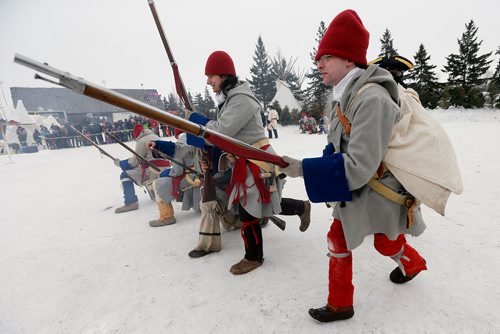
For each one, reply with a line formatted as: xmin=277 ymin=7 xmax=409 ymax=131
xmin=186 ymin=51 xmax=309 ymax=275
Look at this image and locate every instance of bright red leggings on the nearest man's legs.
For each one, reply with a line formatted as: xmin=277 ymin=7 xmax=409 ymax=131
xmin=327 ymin=219 xmax=427 ymax=307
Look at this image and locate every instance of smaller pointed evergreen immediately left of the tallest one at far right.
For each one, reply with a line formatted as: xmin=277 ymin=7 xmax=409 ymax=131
xmin=407 ymin=44 xmax=439 ymax=109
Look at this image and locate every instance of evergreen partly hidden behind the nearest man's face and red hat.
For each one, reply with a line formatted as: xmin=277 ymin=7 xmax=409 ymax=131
xmin=305 ymin=21 xmax=331 ymax=118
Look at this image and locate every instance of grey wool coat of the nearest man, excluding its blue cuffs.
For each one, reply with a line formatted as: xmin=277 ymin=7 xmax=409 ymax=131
xmin=326 ymin=65 xmax=425 ymax=250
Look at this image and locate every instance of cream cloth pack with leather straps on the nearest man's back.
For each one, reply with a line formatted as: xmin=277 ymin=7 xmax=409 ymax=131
xmin=337 ymin=83 xmax=463 ymax=219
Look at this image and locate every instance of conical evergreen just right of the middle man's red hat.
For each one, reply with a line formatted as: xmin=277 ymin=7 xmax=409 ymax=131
xmin=247 ymin=35 xmax=276 ymax=109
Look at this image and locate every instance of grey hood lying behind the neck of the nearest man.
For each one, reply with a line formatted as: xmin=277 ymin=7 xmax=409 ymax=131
xmin=340 ymin=65 xmax=399 ymax=106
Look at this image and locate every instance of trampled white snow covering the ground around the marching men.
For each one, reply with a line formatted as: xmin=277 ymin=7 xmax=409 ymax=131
xmin=0 ymin=110 xmax=500 ymax=333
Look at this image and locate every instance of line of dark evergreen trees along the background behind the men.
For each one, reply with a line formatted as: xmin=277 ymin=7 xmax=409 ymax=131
xmin=164 ymin=20 xmax=500 ymax=124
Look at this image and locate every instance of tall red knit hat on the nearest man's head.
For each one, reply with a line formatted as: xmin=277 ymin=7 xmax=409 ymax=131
xmin=315 ymin=9 xmax=370 ymax=65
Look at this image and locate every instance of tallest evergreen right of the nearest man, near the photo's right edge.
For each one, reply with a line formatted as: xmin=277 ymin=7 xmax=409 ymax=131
xmin=443 ymin=20 xmax=492 ymax=108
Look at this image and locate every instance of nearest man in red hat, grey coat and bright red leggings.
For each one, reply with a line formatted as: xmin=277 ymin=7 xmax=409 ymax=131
xmin=282 ymin=10 xmax=427 ymax=322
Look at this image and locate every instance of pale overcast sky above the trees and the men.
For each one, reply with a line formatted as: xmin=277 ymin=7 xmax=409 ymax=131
xmin=0 ymin=0 xmax=500 ymax=107
